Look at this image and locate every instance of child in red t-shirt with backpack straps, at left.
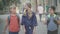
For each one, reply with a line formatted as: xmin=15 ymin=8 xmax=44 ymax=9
xmin=4 ymin=5 xmax=20 ymax=34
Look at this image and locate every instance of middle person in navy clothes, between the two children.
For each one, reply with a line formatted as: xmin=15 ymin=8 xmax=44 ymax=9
xmin=21 ymin=3 xmax=37 ymax=34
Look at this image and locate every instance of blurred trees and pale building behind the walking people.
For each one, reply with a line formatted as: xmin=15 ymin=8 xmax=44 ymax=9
xmin=0 ymin=0 xmax=60 ymax=14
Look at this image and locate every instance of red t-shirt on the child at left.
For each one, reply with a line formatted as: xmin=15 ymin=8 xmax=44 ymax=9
xmin=9 ymin=16 xmax=20 ymax=32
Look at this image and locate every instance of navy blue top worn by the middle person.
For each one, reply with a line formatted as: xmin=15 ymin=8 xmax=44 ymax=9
xmin=21 ymin=13 xmax=37 ymax=26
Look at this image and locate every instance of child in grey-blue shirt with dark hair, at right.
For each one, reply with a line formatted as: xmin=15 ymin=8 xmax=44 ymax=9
xmin=43 ymin=6 xmax=60 ymax=34
